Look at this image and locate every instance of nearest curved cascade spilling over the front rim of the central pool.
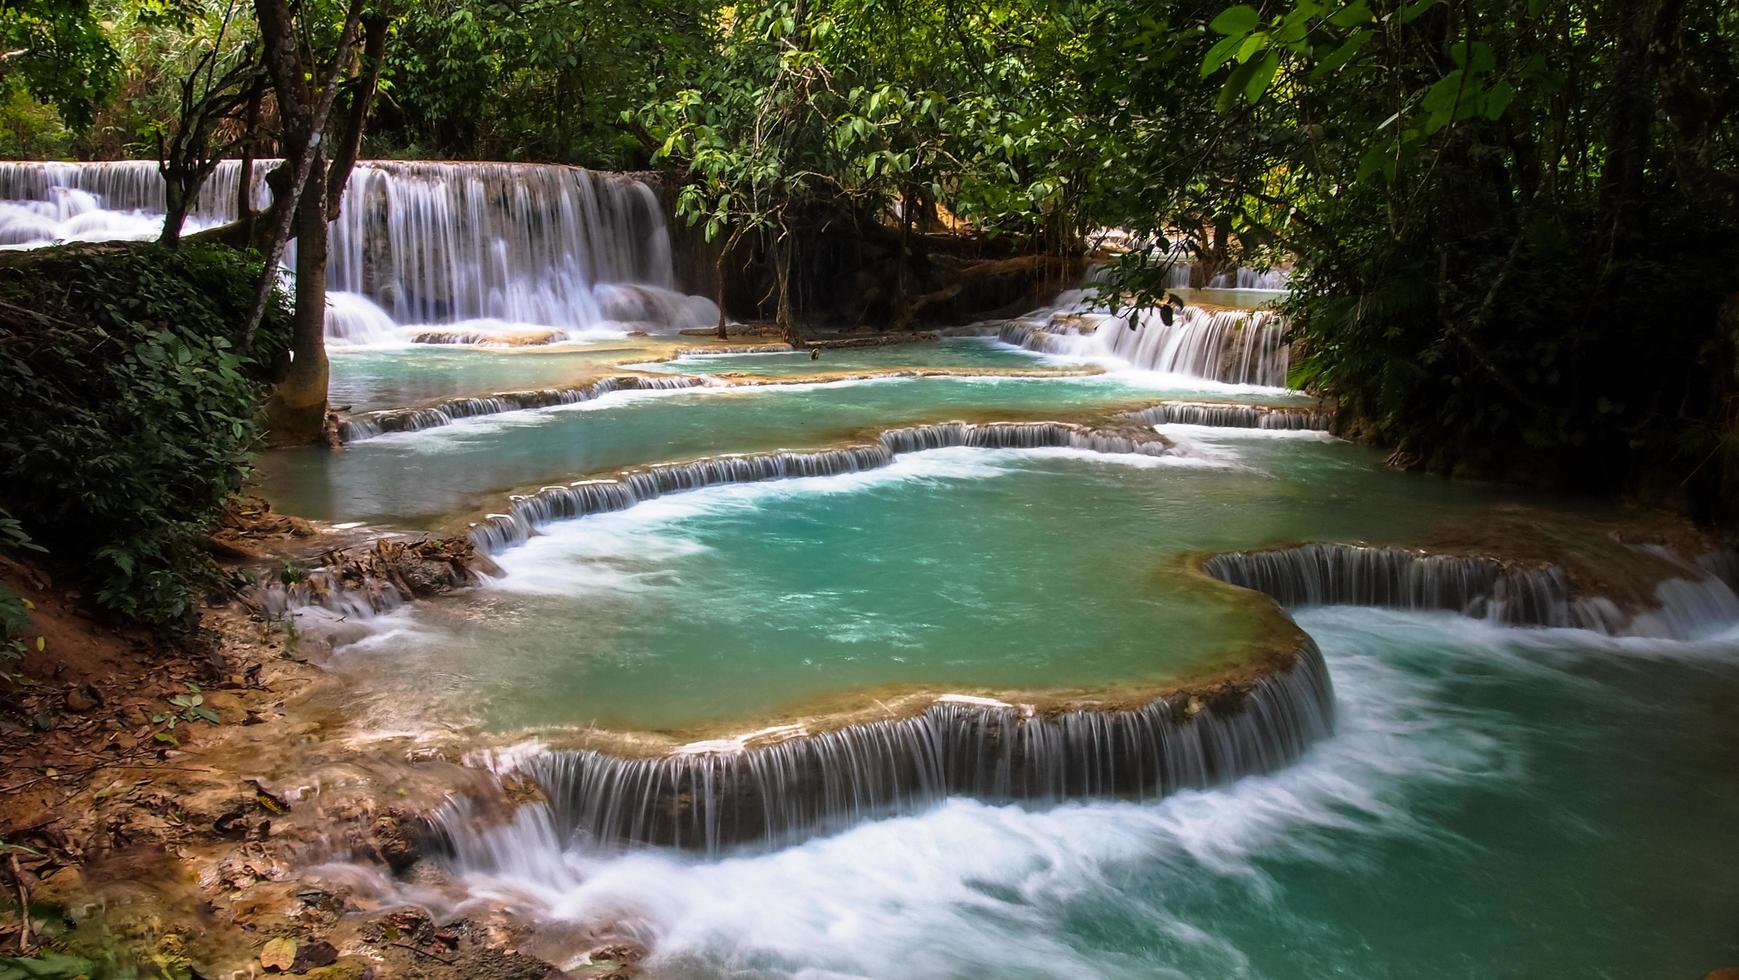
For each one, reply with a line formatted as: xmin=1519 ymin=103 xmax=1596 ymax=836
xmin=436 ymin=638 xmax=1334 ymax=851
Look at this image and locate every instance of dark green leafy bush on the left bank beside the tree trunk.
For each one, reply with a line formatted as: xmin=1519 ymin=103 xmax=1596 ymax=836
xmin=0 ymin=243 xmax=290 ymax=627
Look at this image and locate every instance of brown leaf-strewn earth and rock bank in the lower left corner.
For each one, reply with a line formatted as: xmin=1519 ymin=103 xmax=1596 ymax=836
xmin=0 ymin=552 xmax=546 ymax=977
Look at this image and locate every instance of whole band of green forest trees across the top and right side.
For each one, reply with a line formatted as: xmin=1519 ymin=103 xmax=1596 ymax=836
xmin=0 ymin=0 xmax=1739 ymax=514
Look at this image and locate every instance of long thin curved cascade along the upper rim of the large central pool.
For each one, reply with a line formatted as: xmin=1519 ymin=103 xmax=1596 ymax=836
xmin=471 ymin=422 xmax=1177 ymax=554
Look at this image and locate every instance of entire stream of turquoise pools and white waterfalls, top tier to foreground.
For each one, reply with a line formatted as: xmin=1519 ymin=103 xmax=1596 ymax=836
xmin=0 ymin=163 xmax=1739 ymax=980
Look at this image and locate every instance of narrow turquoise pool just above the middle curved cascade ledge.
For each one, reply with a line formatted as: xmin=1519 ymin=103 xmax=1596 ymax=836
xmin=261 ymin=370 xmax=1293 ymax=525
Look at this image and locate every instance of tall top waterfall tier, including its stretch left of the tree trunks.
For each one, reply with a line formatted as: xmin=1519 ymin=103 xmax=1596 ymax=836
xmin=0 ymin=160 xmax=718 ymax=342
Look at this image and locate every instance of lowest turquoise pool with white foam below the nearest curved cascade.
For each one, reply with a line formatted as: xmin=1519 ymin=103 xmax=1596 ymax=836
xmin=431 ymin=608 xmax=1739 ymax=980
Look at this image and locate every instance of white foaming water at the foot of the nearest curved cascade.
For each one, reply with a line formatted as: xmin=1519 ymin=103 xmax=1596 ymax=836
xmin=323 ymin=612 xmax=1522 ymax=978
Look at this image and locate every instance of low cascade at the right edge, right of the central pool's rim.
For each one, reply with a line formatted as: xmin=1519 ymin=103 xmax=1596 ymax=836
xmin=1202 ymin=544 xmax=1739 ymax=639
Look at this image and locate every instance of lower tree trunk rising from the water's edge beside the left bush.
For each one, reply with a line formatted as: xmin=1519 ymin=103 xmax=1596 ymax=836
xmin=266 ymin=160 xmax=329 ymax=445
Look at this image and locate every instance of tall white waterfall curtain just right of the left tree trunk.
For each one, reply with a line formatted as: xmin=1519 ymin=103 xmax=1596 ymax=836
xmin=330 ymin=163 xmax=718 ymax=330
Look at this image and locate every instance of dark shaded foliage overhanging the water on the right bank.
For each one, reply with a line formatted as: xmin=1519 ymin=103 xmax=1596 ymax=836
xmin=1147 ymin=0 xmax=1739 ymax=516
